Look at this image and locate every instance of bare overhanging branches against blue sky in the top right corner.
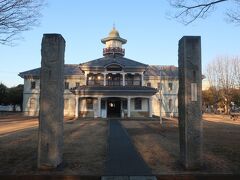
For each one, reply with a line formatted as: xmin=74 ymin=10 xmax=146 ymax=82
xmin=169 ymin=0 xmax=240 ymax=25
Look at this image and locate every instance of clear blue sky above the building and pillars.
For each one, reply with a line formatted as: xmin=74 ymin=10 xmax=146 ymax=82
xmin=0 ymin=0 xmax=240 ymax=87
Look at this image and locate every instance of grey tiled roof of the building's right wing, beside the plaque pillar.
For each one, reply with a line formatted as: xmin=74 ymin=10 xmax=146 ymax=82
xmin=145 ymin=65 xmax=178 ymax=78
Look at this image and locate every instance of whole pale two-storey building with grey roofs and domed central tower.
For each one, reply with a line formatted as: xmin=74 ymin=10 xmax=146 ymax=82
xmin=19 ymin=28 xmax=178 ymax=118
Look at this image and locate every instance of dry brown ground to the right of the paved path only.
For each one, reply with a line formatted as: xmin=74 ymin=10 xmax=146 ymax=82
xmin=122 ymin=114 xmax=240 ymax=175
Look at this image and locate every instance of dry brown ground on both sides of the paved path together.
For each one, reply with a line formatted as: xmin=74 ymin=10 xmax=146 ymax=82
xmin=0 ymin=114 xmax=240 ymax=175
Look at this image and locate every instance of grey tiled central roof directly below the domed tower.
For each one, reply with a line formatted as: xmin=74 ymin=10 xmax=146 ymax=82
xmin=80 ymin=55 xmax=148 ymax=68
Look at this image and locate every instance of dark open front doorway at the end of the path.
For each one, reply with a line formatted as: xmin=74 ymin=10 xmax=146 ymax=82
xmin=107 ymin=98 xmax=121 ymax=117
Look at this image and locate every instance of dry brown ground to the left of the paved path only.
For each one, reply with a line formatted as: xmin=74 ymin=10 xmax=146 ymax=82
xmin=0 ymin=114 xmax=107 ymax=175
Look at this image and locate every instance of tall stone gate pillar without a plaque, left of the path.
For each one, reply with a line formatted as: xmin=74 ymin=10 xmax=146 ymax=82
xmin=38 ymin=34 xmax=65 ymax=169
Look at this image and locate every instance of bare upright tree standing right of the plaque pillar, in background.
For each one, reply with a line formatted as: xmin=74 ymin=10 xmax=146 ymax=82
xmin=207 ymin=56 xmax=240 ymax=114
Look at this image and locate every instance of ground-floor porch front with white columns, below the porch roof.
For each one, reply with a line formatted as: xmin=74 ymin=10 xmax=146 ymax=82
xmin=75 ymin=97 xmax=152 ymax=118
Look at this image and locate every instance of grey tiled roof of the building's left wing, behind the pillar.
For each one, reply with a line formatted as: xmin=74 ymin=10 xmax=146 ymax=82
xmin=18 ymin=64 xmax=83 ymax=78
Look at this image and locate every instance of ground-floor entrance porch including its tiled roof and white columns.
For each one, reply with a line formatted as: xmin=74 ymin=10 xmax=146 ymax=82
xmin=72 ymin=86 xmax=156 ymax=118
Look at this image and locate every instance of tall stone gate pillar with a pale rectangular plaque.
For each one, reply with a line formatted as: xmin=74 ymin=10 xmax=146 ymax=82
xmin=178 ymin=36 xmax=202 ymax=169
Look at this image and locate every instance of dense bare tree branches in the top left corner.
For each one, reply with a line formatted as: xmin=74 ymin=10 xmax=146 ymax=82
xmin=0 ymin=0 xmax=44 ymax=45
